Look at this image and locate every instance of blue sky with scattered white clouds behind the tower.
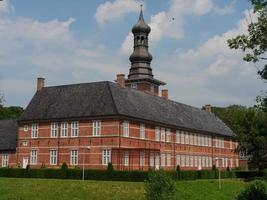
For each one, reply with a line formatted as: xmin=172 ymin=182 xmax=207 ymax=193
xmin=0 ymin=0 xmax=265 ymax=107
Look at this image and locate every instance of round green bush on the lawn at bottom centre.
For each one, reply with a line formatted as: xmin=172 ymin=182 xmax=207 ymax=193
xmin=145 ymin=170 xmax=175 ymax=200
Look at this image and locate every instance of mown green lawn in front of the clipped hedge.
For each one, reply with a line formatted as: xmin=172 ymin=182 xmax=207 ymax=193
xmin=0 ymin=178 xmax=260 ymax=200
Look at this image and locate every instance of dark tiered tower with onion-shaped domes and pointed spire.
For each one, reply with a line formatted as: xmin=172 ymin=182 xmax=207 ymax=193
xmin=125 ymin=8 xmax=165 ymax=95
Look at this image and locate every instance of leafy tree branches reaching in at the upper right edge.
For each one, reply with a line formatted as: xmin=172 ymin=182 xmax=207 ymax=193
xmin=227 ymin=0 xmax=267 ymax=108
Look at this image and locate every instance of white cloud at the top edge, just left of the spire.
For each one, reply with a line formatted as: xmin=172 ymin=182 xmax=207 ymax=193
xmin=94 ymin=0 xmax=141 ymax=26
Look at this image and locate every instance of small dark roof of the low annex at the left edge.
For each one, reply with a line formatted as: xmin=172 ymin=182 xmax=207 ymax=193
xmin=0 ymin=120 xmax=18 ymax=151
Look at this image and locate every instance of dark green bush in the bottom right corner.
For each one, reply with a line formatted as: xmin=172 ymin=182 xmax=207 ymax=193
xmin=236 ymin=181 xmax=267 ymax=200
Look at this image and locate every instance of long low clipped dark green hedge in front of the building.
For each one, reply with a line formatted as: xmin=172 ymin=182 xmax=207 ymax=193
xmin=0 ymin=168 xmax=262 ymax=182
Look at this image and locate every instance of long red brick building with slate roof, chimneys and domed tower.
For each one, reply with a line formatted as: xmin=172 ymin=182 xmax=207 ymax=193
xmin=0 ymin=11 xmax=239 ymax=170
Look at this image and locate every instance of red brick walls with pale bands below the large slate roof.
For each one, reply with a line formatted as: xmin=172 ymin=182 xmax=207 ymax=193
xmin=1 ymin=118 xmax=238 ymax=170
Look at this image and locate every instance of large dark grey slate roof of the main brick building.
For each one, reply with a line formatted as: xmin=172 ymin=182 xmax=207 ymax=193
xmin=20 ymin=81 xmax=233 ymax=136
